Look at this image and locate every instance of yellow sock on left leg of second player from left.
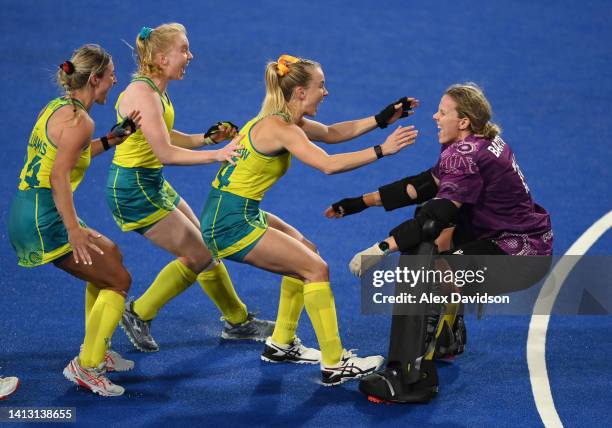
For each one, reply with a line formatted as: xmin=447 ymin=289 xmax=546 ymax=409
xmin=134 ymin=259 xmax=196 ymax=320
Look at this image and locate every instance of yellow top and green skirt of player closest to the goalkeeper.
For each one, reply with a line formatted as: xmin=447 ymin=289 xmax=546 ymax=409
xmin=200 ymin=113 xmax=291 ymax=261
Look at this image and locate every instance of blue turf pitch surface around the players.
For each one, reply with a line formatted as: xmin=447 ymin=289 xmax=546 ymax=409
xmin=0 ymin=0 xmax=612 ymax=427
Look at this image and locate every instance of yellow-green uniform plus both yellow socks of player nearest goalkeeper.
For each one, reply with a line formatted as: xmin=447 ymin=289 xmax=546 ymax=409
xmin=200 ymin=115 xmax=342 ymax=365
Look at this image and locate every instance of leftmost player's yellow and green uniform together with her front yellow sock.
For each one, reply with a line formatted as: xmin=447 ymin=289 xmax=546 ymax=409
xmin=9 ymin=98 xmax=125 ymax=367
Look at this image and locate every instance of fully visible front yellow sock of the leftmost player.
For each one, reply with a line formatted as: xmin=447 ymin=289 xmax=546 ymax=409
xmin=79 ymin=290 xmax=125 ymax=367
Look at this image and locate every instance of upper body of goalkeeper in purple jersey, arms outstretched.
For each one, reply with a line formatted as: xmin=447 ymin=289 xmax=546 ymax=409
xmin=325 ymin=84 xmax=552 ymax=264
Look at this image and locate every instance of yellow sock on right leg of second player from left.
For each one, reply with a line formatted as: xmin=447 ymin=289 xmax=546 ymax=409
xmin=198 ymin=262 xmax=248 ymax=324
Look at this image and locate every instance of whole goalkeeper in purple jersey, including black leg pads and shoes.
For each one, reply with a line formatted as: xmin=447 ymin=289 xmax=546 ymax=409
xmin=325 ymin=83 xmax=553 ymax=403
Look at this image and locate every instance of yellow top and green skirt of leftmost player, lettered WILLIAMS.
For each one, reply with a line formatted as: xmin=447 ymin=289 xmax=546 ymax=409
xmin=8 ymin=98 xmax=91 ymax=267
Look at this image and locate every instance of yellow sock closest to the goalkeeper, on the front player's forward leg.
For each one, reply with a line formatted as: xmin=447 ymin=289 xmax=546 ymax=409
xmin=304 ymin=282 xmax=342 ymax=366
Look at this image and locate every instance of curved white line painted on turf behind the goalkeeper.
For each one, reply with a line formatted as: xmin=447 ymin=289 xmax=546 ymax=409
xmin=527 ymin=211 xmax=612 ymax=428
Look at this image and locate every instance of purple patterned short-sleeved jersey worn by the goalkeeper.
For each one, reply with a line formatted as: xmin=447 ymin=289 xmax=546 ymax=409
xmin=432 ymin=135 xmax=552 ymax=255
